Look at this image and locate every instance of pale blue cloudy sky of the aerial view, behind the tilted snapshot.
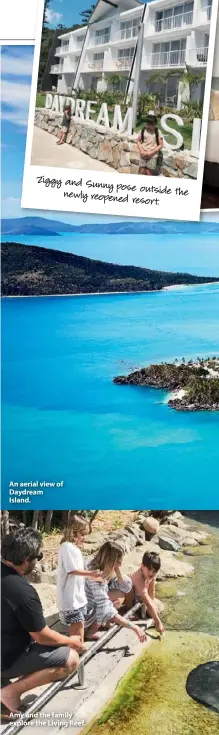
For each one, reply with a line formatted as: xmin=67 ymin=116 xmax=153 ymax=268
xmin=2 ymin=46 xmax=219 ymax=225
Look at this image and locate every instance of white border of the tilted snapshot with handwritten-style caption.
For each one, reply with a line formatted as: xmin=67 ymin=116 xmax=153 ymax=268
xmin=21 ymin=0 xmax=219 ymax=221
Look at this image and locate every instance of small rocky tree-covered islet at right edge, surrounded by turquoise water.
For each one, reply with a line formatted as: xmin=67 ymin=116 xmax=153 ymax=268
xmin=113 ymin=357 xmax=219 ymax=411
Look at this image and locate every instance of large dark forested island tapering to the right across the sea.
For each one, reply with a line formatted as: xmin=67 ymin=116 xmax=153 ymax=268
xmin=2 ymin=242 xmax=219 ymax=296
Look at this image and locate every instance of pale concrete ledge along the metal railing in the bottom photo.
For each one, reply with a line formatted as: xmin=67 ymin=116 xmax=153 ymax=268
xmin=1 ymin=620 xmax=158 ymax=735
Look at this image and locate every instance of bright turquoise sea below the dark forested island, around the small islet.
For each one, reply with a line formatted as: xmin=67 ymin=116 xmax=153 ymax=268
xmin=2 ymin=284 xmax=219 ymax=509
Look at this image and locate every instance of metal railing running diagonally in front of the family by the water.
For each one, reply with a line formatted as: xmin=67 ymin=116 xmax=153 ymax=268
xmin=4 ymin=602 xmax=141 ymax=735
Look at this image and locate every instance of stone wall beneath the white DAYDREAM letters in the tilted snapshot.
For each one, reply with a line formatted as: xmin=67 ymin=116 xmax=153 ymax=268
xmin=35 ymin=108 xmax=198 ymax=179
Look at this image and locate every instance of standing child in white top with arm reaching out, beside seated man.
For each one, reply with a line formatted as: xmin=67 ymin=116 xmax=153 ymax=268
xmin=57 ymin=516 xmax=103 ymax=642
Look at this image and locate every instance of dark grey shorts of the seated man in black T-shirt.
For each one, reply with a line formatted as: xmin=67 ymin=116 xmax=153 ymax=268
xmin=2 ymin=643 xmax=70 ymax=685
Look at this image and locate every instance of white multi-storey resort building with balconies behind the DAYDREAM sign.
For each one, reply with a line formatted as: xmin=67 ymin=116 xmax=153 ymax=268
xmin=50 ymin=0 xmax=212 ymax=108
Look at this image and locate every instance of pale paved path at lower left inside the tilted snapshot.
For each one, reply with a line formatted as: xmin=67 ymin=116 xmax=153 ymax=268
xmin=31 ymin=127 xmax=113 ymax=173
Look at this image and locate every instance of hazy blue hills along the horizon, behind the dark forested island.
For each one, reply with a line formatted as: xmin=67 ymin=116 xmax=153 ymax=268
xmin=1 ymin=216 xmax=219 ymax=237
